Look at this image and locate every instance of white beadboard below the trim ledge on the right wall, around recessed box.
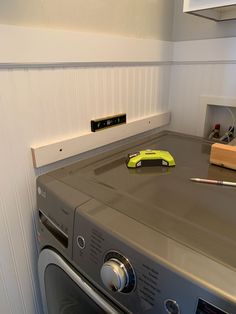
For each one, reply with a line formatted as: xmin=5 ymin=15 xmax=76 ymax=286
xmin=170 ymin=64 xmax=236 ymax=136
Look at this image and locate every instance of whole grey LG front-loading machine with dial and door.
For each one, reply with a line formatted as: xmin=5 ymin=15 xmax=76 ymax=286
xmin=37 ymin=132 xmax=236 ymax=314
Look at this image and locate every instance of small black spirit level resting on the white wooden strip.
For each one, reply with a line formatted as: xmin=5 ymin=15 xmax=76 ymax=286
xmin=91 ymin=113 xmax=126 ymax=132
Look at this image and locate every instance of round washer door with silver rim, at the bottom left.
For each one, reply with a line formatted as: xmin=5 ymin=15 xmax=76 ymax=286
xmin=38 ymin=249 xmax=124 ymax=314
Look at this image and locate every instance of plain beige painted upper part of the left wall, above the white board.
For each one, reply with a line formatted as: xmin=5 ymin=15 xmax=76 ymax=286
xmin=0 ymin=0 xmax=174 ymax=40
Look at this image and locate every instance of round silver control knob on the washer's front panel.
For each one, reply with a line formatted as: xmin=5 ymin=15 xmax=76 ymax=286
xmin=100 ymin=252 xmax=135 ymax=293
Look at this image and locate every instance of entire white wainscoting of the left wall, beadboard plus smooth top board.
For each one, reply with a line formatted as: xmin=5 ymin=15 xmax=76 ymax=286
xmin=0 ymin=1 xmax=172 ymax=314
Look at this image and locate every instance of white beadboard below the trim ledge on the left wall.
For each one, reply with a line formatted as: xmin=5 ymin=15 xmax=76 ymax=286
xmin=0 ymin=65 xmax=170 ymax=314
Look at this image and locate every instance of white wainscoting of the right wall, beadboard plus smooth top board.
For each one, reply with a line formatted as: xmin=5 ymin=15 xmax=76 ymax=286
xmin=170 ymin=37 xmax=236 ymax=136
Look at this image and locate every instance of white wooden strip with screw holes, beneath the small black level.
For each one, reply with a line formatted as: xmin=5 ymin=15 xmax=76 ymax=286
xmin=31 ymin=112 xmax=170 ymax=168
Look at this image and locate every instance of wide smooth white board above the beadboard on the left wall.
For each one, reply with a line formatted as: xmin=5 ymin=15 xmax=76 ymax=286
xmin=0 ymin=25 xmax=173 ymax=64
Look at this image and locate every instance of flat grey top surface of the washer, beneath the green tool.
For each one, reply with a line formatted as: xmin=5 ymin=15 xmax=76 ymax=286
xmin=51 ymin=132 xmax=236 ymax=270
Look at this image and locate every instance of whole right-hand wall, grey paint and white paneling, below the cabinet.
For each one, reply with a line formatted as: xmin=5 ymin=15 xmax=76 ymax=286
xmin=169 ymin=0 xmax=236 ymax=136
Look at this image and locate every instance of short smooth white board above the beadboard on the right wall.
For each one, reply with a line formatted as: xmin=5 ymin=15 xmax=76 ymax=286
xmin=173 ymin=37 xmax=236 ymax=62
